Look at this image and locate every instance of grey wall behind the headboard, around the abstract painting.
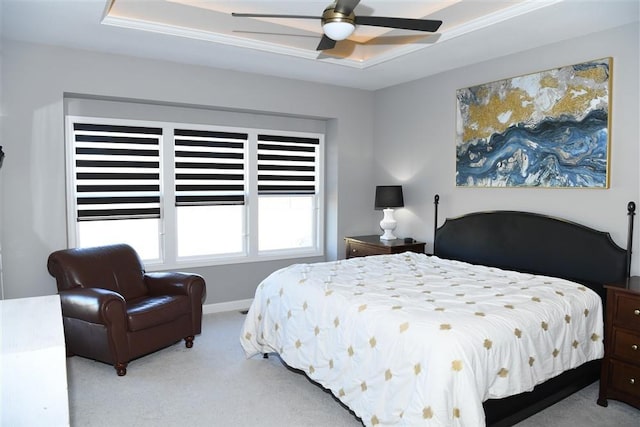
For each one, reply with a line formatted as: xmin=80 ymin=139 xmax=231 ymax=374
xmin=374 ymin=23 xmax=640 ymax=274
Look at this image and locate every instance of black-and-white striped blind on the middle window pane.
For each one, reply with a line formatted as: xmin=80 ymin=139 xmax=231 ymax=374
xmin=174 ymin=129 xmax=249 ymax=206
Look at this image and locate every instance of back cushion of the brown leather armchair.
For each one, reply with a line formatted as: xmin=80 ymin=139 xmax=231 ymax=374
xmin=48 ymin=244 xmax=148 ymax=301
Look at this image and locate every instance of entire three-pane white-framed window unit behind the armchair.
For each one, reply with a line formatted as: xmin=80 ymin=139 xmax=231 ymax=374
xmin=67 ymin=116 xmax=323 ymax=268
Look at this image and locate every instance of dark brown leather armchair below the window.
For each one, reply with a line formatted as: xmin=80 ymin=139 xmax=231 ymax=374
xmin=47 ymin=244 xmax=206 ymax=376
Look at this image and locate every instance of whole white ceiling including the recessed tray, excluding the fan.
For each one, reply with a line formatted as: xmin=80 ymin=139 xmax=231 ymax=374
xmin=0 ymin=0 xmax=640 ymax=90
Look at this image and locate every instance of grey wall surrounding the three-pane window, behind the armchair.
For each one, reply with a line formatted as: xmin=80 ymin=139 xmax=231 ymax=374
xmin=0 ymin=40 xmax=373 ymax=304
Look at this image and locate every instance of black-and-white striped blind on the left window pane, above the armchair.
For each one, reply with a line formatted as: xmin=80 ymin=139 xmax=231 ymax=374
xmin=73 ymin=123 xmax=162 ymax=221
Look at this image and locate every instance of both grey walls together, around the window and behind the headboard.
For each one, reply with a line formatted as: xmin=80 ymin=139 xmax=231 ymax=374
xmin=0 ymin=23 xmax=640 ymax=304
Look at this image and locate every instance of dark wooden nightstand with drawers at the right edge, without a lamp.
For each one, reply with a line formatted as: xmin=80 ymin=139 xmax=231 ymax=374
xmin=598 ymin=276 xmax=640 ymax=408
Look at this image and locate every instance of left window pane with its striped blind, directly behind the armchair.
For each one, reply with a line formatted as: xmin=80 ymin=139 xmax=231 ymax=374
xmin=70 ymin=123 xmax=162 ymax=260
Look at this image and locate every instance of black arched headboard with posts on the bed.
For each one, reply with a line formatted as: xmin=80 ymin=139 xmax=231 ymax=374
xmin=433 ymin=195 xmax=635 ymax=293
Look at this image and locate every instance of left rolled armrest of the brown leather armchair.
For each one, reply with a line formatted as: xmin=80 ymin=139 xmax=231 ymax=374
xmin=59 ymin=288 xmax=126 ymax=325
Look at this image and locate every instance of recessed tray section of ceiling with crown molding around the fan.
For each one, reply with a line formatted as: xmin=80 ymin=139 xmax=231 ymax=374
xmin=102 ymin=0 xmax=536 ymax=68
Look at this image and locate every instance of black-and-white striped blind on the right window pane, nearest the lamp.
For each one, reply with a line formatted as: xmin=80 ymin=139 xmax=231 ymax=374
xmin=258 ymin=135 xmax=320 ymax=195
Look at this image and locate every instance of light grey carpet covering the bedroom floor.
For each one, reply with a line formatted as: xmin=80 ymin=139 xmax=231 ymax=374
xmin=67 ymin=312 xmax=640 ymax=427
